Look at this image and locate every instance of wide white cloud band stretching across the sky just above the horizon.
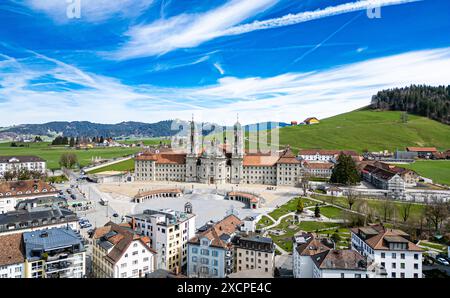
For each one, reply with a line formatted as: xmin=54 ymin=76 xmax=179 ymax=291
xmin=0 ymin=48 xmax=450 ymax=125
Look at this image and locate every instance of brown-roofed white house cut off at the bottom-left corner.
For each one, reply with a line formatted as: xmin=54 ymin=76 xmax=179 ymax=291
xmin=0 ymin=233 xmax=25 ymax=278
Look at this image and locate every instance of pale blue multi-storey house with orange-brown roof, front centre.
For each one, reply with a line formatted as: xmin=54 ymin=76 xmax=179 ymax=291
xmin=187 ymin=214 xmax=242 ymax=278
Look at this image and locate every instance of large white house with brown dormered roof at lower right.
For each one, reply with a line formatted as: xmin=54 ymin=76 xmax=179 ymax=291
xmin=351 ymin=225 xmax=422 ymax=278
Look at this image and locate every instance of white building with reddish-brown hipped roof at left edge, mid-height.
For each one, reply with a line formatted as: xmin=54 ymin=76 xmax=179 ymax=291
xmin=0 ymin=180 xmax=58 ymax=214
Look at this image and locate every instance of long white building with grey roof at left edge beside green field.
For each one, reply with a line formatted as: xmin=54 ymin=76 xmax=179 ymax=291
xmin=0 ymin=155 xmax=47 ymax=178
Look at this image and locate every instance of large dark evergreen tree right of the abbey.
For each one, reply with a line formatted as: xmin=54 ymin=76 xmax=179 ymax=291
xmin=330 ymin=153 xmax=361 ymax=185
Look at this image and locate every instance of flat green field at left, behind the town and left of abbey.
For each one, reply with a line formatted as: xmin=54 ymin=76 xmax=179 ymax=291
xmin=0 ymin=142 xmax=141 ymax=169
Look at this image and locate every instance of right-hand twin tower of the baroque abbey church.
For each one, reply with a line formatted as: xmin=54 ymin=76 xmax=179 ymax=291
xmin=230 ymin=116 xmax=244 ymax=184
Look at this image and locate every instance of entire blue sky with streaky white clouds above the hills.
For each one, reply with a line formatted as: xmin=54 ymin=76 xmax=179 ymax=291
xmin=0 ymin=0 xmax=450 ymax=126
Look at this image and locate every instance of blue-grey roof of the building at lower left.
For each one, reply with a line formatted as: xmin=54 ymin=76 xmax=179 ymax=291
xmin=23 ymin=228 xmax=84 ymax=259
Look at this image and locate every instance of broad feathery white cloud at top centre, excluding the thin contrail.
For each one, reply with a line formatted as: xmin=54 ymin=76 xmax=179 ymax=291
xmin=109 ymin=0 xmax=278 ymax=59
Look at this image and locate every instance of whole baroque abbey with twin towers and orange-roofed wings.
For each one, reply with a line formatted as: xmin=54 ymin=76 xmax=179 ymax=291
xmin=135 ymin=121 xmax=302 ymax=186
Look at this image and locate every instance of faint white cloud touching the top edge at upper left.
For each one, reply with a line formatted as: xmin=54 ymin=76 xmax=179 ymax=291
xmin=25 ymin=0 xmax=153 ymax=23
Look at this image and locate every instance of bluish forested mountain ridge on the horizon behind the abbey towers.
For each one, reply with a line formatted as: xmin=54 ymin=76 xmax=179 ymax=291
xmin=0 ymin=120 xmax=288 ymax=139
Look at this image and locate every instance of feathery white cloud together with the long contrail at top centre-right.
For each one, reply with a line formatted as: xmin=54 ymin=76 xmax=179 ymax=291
xmin=110 ymin=0 xmax=421 ymax=60
